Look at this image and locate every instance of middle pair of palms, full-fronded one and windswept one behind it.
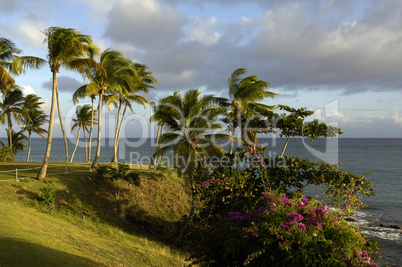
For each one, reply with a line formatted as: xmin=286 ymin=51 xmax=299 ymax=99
xmin=150 ymin=68 xmax=278 ymax=189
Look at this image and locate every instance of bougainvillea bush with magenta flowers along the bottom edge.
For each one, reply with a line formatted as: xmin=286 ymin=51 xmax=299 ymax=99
xmin=186 ymin=192 xmax=378 ymax=266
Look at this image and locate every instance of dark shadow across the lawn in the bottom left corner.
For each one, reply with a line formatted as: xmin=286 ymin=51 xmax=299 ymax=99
xmin=0 ymin=238 xmax=102 ymax=267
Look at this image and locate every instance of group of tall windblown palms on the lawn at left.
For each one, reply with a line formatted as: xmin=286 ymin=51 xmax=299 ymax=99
xmin=0 ymin=27 xmax=156 ymax=180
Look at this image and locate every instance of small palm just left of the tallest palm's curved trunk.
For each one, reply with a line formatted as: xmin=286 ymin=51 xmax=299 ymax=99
xmin=21 ymin=94 xmax=49 ymax=162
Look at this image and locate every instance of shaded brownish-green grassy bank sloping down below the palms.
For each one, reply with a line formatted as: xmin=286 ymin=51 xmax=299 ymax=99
xmin=56 ymin=173 xmax=188 ymax=244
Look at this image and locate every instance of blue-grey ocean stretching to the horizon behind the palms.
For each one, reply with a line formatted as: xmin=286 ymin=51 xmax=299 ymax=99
xmin=16 ymin=138 xmax=402 ymax=266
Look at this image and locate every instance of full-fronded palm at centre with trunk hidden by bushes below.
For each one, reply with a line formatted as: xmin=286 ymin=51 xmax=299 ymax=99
xmin=154 ymin=89 xmax=236 ymax=188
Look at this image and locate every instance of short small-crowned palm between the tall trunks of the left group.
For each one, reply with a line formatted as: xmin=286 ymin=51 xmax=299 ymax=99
xmin=70 ymin=105 xmax=96 ymax=162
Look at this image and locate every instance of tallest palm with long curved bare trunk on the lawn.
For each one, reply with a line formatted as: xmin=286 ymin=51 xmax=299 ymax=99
xmin=36 ymin=27 xmax=98 ymax=180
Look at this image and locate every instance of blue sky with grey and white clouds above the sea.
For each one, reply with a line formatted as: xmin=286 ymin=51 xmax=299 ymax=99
xmin=0 ymin=0 xmax=402 ymax=138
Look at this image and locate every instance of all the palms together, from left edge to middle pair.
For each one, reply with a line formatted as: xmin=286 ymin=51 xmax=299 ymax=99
xmin=0 ymin=27 xmax=277 ymax=180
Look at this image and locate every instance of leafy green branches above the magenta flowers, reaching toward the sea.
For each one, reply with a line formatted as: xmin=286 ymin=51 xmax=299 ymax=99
xmin=238 ymin=146 xmax=374 ymax=216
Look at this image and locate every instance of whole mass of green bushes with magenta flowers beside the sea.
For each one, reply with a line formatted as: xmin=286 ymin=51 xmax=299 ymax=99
xmin=185 ymin=148 xmax=379 ymax=266
